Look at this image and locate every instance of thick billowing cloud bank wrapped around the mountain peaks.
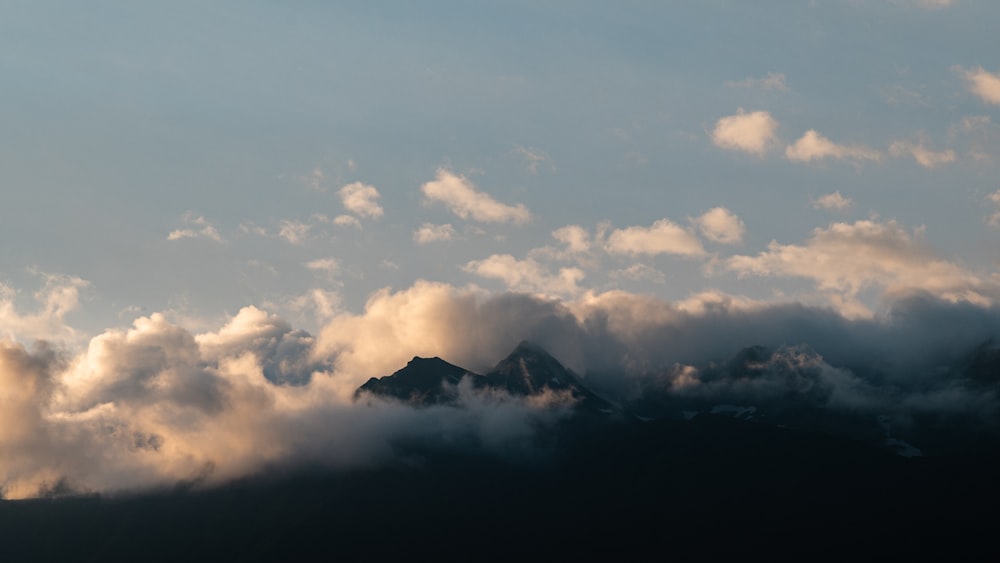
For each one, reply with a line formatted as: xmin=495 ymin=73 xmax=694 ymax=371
xmin=0 ymin=274 xmax=1000 ymax=498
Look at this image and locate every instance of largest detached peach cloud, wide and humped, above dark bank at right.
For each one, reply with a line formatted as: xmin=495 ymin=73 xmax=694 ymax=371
xmin=725 ymin=220 xmax=1000 ymax=316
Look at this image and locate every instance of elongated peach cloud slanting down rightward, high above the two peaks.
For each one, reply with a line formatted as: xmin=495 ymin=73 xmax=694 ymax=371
xmin=421 ymin=168 xmax=531 ymax=224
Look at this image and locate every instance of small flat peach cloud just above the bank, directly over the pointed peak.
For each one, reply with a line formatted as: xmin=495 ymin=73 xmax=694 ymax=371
xmin=462 ymin=254 xmax=585 ymax=295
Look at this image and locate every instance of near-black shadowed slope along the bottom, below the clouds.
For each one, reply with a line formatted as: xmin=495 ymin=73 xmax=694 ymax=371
xmin=0 ymin=415 xmax=1000 ymax=561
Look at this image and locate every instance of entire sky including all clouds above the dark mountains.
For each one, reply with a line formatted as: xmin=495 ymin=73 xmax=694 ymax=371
xmin=0 ymin=0 xmax=1000 ymax=495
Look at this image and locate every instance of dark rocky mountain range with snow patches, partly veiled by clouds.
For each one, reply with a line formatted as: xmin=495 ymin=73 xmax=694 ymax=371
xmin=354 ymin=341 xmax=1000 ymax=457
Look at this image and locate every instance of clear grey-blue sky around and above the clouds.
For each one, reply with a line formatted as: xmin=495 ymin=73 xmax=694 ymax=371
xmin=0 ymin=0 xmax=1000 ymax=340
